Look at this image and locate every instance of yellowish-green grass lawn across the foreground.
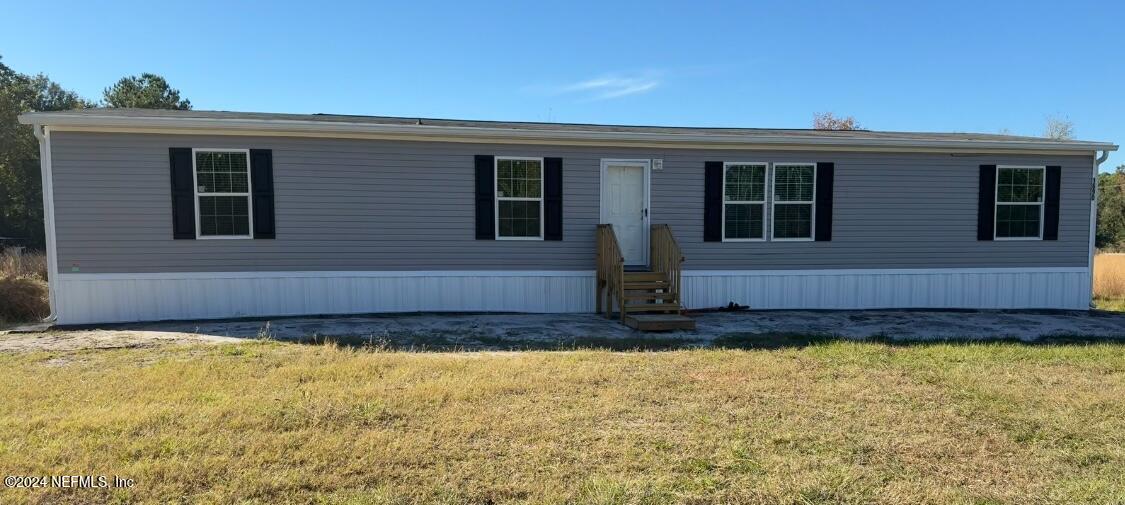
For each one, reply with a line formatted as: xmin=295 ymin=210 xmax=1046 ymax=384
xmin=0 ymin=342 xmax=1125 ymax=504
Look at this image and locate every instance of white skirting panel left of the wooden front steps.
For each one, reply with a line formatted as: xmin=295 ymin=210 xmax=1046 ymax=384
xmin=56 ymin=271 xmax=594 ymax=324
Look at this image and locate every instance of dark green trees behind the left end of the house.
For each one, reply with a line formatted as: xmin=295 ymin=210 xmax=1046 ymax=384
xmin=0 ymin=55 xmax=191 ymax=250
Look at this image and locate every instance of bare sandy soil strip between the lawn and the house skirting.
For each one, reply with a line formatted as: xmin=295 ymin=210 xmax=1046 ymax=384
xmin=0 ymin=310 xmax=1125 ymax=352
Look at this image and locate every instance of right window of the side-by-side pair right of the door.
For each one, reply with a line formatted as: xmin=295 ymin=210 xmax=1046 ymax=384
xmin=770 ymin=163 xmax=817 ymax=241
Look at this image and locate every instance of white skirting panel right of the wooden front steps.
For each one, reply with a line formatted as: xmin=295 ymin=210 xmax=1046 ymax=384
xmin=683 ymin=268 xmax=1090 ymax=310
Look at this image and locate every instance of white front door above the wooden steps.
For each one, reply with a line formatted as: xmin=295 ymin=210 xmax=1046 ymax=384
xmin=602 ymin=160 xmax=648 ymax=265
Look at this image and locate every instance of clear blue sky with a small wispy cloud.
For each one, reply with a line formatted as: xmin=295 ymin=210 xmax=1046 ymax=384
xmin=0 ymin=0 xmax=1125 ymax=169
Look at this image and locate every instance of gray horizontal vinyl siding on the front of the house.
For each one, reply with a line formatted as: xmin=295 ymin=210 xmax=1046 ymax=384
xmin=52 ymin=132 xmax=1092 ymax=272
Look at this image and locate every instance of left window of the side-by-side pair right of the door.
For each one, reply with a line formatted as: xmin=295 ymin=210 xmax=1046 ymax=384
xmin=722 ymin=162 xmax=770 ymax=242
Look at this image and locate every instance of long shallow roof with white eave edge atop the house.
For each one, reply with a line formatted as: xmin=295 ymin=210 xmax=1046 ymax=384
xmin=19 ymin=111 xmax=1118 ymax=152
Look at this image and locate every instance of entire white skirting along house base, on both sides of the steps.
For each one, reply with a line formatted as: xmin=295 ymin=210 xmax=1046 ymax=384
xmin=56 ymin=268 xmax=1090 ymax=324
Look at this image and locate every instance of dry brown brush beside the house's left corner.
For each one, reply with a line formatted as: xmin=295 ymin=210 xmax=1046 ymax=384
xmin=0 ymin=253 xmax=51 ymax=324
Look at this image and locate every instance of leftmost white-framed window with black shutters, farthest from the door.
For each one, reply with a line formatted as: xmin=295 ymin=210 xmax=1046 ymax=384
xmin=191 ymin=148 xmax=254 ymax=238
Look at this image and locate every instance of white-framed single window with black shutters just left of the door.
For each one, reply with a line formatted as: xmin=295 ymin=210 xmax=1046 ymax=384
xmin=495 ymin=156 xmax=543 ymax=241
